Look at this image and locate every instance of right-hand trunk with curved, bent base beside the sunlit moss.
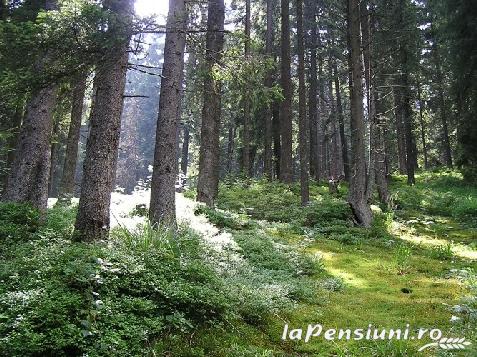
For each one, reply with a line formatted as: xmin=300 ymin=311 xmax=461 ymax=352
xmin=348 ymin=0 xmax=373 ymax=227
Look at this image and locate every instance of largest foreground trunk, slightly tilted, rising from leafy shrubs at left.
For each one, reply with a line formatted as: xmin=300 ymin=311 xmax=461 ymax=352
xmin=75 ymin=0 xmax=134 ymax=241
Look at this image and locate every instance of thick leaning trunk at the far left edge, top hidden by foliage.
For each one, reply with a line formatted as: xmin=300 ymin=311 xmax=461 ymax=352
xmin=3 ymin=84 xmax=57 ymax=212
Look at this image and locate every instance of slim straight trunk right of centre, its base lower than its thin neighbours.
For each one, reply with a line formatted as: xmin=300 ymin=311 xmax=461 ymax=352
xmin=296 ymin=0 xmax=310 ymax=206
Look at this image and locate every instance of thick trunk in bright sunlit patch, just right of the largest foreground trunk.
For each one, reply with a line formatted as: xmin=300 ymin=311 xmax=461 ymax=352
xmin=149 ymin=0 xmax=187 ymax=226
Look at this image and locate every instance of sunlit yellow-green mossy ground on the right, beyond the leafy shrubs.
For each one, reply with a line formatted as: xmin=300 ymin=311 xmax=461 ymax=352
xmin=184 ymin=172 xmax=477 ymax=356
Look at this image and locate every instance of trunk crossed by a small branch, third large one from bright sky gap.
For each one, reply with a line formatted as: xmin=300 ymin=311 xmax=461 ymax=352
xmin=197 ymin=0 xmax=225 ymax=206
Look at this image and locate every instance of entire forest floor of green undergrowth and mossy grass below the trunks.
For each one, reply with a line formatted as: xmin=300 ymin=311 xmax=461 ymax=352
xmin=0 ymin=172 xmax=477 ymax=357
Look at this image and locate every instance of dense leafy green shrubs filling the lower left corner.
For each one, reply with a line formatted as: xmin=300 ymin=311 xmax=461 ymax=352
xmin=0 ymin=213 xmax=233 ymax=356
